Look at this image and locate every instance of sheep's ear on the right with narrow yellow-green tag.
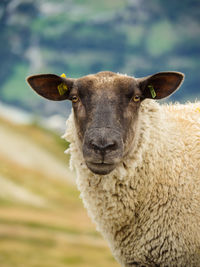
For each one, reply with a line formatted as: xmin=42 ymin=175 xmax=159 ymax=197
xmin=138 ymin=72 xmax=184 ymax=99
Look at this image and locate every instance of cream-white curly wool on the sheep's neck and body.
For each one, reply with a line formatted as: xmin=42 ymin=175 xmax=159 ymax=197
xmin=64 ymin=100 xmax=200 ymax=267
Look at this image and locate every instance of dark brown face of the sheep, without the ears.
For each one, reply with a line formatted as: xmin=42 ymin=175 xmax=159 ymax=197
xmin=69 ymin=72 xmax=142 ymax=174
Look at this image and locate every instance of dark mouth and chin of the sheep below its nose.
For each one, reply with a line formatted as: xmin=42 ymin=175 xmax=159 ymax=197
xmin=86 ymin=162 xmax=116 ymax=175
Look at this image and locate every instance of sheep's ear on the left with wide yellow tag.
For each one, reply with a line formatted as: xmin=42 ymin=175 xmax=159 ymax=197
xmin=27 ymin=74 xmax=74 ymax=101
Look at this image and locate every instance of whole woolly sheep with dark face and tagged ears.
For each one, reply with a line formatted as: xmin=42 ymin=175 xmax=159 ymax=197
xmin=27 ymin=71 xmax=200 ymax=267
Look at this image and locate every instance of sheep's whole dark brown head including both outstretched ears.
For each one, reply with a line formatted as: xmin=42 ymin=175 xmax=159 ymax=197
xmin=28 ymin=72 xmax=183 ymax=175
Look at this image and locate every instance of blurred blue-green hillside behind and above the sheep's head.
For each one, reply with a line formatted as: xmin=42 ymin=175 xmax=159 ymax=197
xmin=0 ymin=0 xmax=200 ymax=114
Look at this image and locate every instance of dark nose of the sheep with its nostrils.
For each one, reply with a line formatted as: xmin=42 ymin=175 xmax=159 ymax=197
xmin=90 ymin=140 xmax=118 ymax=154
